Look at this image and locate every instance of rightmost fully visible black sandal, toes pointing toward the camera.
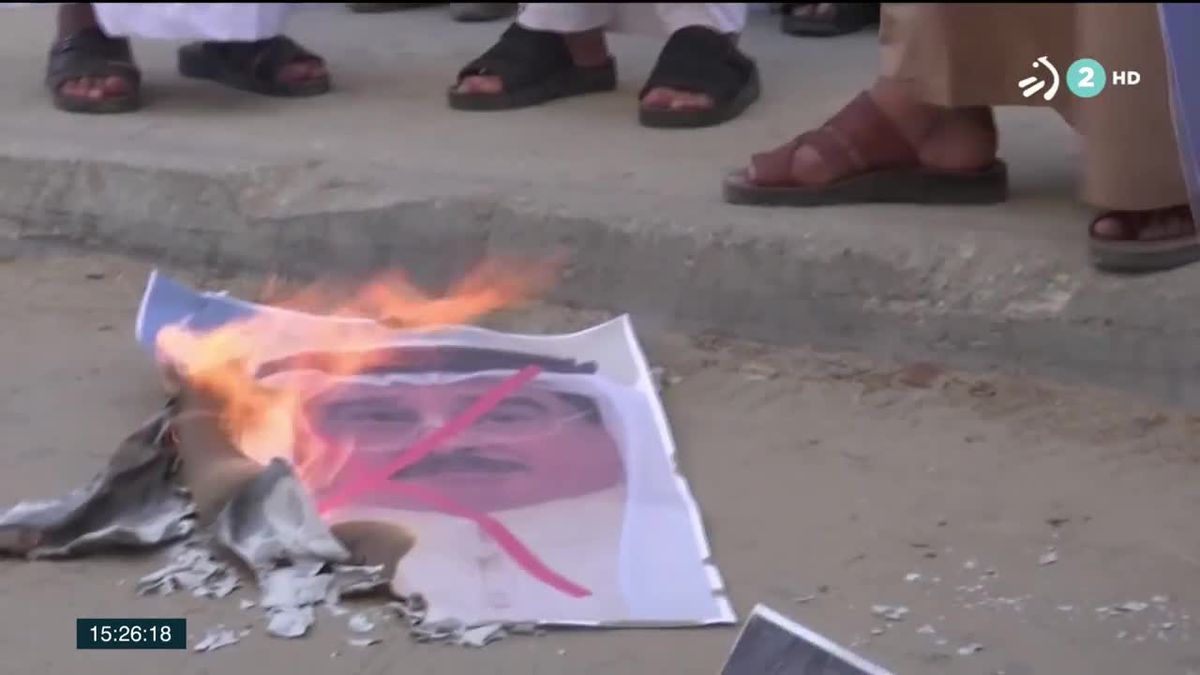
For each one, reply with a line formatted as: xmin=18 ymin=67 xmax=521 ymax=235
xmin=637 ymin=26 xmax=760 ymax=129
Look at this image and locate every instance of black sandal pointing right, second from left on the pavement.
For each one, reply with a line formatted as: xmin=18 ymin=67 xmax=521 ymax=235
xmin=179 ymin=35 xmax=330 ymax=97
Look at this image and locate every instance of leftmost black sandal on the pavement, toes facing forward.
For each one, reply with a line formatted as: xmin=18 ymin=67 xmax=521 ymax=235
xmin=46 ymin=28 xmax=142 ymax=114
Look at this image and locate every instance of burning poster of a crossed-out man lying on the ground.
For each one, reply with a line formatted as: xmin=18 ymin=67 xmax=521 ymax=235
xmin=137 ymin=269 xmax=734 ymax=626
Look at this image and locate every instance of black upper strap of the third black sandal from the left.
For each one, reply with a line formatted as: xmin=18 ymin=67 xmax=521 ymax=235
xmin=458 ymin=23 xmax=575 ymax=91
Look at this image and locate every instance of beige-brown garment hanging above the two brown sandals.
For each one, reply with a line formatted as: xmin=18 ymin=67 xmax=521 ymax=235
xmin=880 ymin=4 xmax=1188 ymax=210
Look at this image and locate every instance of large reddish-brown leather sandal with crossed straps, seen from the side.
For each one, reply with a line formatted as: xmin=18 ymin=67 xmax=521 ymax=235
xmin=724 ymin=92 xmax=1008 ymax=207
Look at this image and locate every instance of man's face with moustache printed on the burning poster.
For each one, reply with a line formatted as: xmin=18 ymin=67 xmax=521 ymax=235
xmin=297 ymin=376 xmax=624 ymax=512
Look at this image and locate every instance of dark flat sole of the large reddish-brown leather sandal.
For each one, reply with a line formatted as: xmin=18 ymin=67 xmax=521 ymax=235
xmin=722 ymin=160 xmax=1008 ymax=207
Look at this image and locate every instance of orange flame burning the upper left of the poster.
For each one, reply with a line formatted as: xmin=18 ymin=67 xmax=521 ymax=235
xmin=157 ymin=254 xmax=556 ymax=480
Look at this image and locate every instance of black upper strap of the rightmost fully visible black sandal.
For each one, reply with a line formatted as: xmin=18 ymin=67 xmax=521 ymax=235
xmin=637 ymin=25 xmax=757 ymax=104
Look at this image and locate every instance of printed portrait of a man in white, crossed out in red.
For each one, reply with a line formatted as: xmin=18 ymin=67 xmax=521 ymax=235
xmin=260 ymin=347 xmax=626 ymax=621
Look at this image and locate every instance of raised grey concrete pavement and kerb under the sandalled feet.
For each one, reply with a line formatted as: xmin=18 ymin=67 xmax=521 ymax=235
xmin=0 ymin=6 xmax=1200 ymax=402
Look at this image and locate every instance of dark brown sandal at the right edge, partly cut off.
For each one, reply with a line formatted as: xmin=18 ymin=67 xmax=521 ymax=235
xmin=1087 ymin=204 xmax=1200 ymax=274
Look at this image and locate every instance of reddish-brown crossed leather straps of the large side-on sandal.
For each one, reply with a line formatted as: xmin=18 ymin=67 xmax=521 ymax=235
xmin=750 ymin=91 xmax=920 ymax=185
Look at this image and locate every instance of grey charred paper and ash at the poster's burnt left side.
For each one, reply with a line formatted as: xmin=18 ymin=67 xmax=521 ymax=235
xmin=0 ymin=400 xmax=388 ymax=634
